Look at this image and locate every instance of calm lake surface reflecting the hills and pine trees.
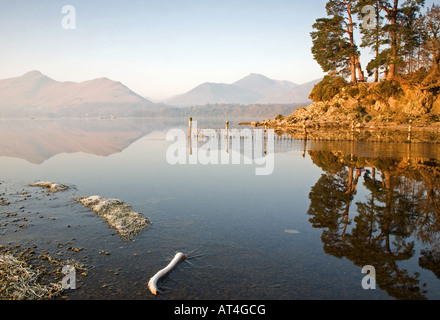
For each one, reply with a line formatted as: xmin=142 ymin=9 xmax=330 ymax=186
xmin=0 ymin=118 xmax=440 ymax=300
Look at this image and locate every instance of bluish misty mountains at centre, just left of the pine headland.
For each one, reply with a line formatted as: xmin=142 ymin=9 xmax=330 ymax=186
xmin=163 ymin=73 xmax=321 ymax=106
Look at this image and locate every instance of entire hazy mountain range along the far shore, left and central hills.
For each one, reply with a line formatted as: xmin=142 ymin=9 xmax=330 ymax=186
xmin=0 ymin=71 xmax=320 ymax=118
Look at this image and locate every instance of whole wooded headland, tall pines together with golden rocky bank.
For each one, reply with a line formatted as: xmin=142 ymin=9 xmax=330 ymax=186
xmin=302 ymin=0 xmax=440 ymax=122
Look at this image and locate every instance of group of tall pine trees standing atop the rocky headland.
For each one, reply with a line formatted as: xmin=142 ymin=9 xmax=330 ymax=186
xmin=311 ymin=0 xmax=432 ymax=83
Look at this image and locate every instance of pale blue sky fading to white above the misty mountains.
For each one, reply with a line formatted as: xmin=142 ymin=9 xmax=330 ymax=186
xmin=0 ymin=0 xmax=434 ymax=100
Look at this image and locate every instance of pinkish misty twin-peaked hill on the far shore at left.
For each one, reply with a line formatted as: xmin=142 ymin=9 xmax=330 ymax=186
xmin=0 ymin=71 xmax=155 ymax=117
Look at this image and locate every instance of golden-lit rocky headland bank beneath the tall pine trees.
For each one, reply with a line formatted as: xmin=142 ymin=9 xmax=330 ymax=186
xmin=241 ymin=77 xmax=440 ymax=143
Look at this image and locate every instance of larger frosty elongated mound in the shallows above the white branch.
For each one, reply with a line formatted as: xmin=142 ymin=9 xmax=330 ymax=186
xmin=74 ymin=196 xmax=150 ymax=239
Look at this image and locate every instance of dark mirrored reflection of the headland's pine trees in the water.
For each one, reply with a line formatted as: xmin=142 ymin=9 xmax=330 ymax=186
xmin=308 ymin=151 xmax=440 ymax=299
